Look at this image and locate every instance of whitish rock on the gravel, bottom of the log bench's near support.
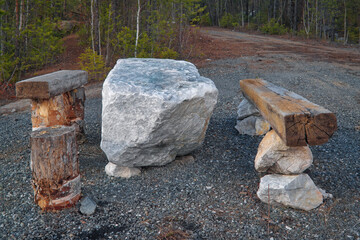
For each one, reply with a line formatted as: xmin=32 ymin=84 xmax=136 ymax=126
xmin=257 ymin=174 xmax=323 ymax=211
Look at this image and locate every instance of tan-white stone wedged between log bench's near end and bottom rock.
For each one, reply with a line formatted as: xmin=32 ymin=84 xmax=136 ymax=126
xmin=255 ymin=130 xmax=313 ymax=174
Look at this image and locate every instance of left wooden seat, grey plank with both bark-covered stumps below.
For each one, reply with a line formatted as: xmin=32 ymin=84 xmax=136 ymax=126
xmin=16 ymin=70 xmax=87 ymax=210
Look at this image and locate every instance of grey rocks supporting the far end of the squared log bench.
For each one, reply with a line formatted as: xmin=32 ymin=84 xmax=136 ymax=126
xmin=235 ymin=98 xmax=270 ymax=136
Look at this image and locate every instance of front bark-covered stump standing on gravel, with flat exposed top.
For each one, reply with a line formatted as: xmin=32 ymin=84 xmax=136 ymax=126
xmin=30 ymin=126 xmax=81 ymax=210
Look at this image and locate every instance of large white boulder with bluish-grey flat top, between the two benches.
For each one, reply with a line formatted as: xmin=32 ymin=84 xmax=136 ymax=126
xmin=101 ymin=59 xmax=218 ymax=167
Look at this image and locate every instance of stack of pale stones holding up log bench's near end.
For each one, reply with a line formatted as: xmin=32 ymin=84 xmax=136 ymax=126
xmin=255 ymin=130 xmax=323 ymax=210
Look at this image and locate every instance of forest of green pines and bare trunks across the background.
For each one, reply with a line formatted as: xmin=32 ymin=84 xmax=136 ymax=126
xmin=0 ymin=0 xmax=360 ymax=88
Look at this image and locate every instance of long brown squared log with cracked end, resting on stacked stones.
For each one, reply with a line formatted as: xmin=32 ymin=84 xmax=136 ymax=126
xmin=240 ymin=79 xmax=337 ymax=147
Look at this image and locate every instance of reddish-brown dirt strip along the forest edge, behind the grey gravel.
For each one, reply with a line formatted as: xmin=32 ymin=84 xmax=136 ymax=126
xmin=200 ymin=28 xmax=360 ymax=71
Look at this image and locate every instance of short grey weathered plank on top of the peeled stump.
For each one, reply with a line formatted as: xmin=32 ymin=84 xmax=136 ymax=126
xmin=16 ymin=70 xmax=88 ymax=99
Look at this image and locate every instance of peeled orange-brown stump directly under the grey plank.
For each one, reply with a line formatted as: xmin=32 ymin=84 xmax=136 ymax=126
xmin=31 ymin=87 xmax=85 ymax=142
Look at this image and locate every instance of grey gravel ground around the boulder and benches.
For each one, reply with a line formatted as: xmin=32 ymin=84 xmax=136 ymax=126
xmin=0 ymin=54 xmax=360 ymax=240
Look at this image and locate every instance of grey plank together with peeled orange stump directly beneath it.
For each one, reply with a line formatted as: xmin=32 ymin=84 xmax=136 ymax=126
xmin=16 ymin=70 xmax=87 ymax=142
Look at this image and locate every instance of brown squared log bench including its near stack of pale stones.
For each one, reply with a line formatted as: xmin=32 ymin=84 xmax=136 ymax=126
xmin=240 ymin=79 xmax=337 ymax=210
